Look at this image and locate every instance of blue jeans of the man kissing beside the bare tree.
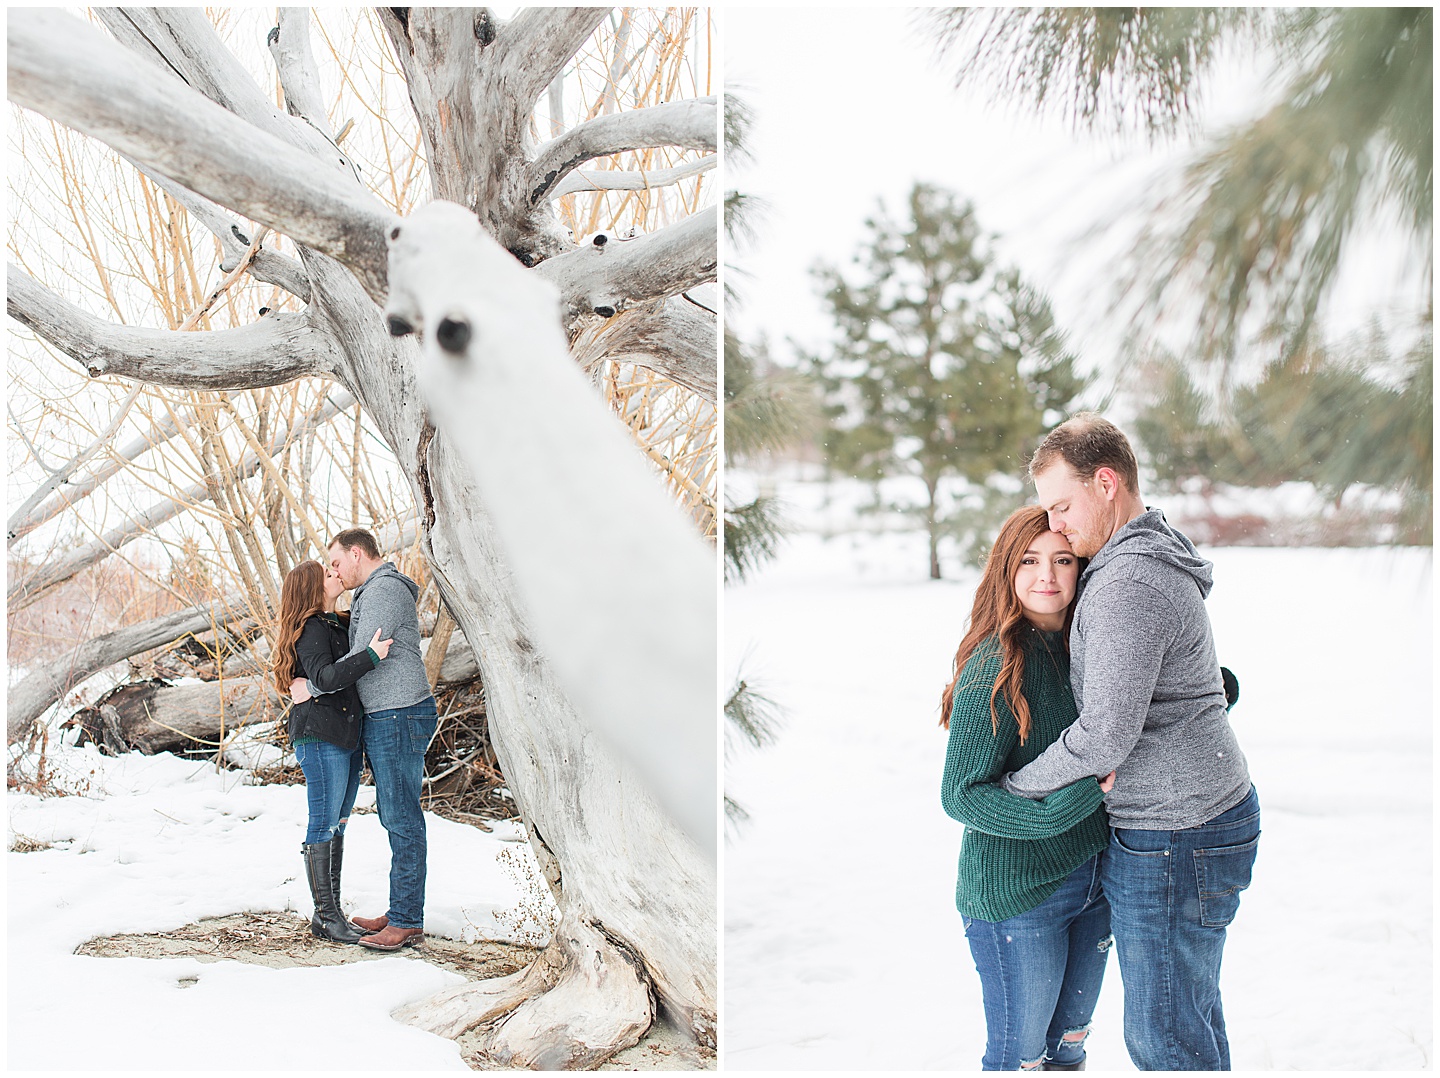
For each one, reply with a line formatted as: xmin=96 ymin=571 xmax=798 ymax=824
xmin=364 ymin=697 xmax=436 ymax=928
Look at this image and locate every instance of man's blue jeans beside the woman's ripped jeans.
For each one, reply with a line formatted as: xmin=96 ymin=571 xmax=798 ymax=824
xmin=1102 ymin=787 xmax=1260 ymax=1071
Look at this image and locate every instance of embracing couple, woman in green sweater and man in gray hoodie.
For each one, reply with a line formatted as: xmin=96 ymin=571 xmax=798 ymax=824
xmin=942 ymin=413 xmax=1260 ymax=1071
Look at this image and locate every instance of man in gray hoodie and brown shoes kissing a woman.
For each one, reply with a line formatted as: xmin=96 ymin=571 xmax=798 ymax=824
xmin=291 ymin=528 xmax=436 ymax=951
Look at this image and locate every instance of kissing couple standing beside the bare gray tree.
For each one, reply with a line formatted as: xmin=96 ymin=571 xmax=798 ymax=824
xmin=271 ymin=528 xmax=436 ymax=951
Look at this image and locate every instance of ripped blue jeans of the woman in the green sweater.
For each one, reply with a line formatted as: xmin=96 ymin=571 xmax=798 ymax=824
xmin=965 ymin=856 xmax=1110 ymax=1071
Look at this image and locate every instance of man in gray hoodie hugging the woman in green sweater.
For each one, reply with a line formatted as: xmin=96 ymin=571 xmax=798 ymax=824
xmin=1002 ymin=413 xmax=1260 ymax=1071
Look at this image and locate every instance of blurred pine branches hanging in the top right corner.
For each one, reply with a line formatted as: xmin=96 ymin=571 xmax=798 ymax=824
xmin=922 ymin=6 xmax=1434 ymax=360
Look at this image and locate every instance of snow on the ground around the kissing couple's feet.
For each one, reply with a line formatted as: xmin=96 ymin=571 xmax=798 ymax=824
xmin=6 ymin=747 xmax=550 ymax=1071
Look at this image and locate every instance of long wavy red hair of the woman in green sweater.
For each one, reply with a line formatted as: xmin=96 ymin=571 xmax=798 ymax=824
xmin=940 ymin=505 xmax=1084 ymax=744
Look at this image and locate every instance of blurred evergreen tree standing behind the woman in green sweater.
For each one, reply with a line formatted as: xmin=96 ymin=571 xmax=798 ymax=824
xmin=809 ymin=183 xmax=1086 ymax=579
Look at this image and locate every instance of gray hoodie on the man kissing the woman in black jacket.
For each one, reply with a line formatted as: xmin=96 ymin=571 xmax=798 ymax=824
xmin=350 ymin=561 xmax=431 ymax=712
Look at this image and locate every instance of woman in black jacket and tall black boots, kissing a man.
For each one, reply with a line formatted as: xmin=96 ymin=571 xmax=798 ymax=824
xmin=271 ymin=561 xmax=390 ymax=943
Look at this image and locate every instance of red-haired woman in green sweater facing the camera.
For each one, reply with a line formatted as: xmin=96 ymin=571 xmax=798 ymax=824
xmin=940 ymin=505 xmax=1115 ymax=1071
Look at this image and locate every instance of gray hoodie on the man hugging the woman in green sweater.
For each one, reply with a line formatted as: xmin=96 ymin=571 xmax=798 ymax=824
xmin=1002 ymin=509 xmax=1250 ymax=830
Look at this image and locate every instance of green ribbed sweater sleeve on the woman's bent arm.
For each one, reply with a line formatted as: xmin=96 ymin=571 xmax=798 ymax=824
xmin=940 ymin=643 xmax=1104 ymax=839
